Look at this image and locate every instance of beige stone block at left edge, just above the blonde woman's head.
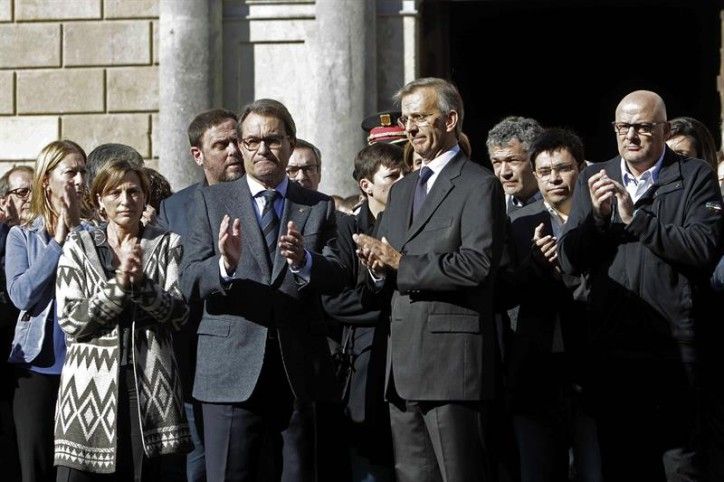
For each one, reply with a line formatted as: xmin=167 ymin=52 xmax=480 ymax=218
xmin=0 ymin=116 xmax=58 ymax=160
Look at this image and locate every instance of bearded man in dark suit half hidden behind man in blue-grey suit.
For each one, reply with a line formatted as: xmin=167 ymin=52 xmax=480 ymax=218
xmin=156 ymin=109 xmax=244 ymax=482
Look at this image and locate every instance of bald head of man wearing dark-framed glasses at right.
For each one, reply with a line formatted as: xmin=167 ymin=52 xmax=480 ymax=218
xmin=616 ymin=90 xmax=669 ymax=176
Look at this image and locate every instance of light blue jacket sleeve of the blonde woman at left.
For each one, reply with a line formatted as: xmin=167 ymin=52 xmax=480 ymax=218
xmin=5 ymin=226 xmax=63 ymax=311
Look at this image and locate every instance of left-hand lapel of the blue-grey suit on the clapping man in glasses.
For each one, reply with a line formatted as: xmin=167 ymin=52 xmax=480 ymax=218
xmin=223 ymin=176 xmax=270 ymax=279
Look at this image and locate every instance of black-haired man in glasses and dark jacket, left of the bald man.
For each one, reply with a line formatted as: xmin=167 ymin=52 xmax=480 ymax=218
xmin=500 ymin=129 xmax=602 ymax=482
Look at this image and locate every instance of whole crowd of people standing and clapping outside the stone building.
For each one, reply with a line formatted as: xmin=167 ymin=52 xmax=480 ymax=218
xmin=0 ymin=78 xmax=724 ymax=482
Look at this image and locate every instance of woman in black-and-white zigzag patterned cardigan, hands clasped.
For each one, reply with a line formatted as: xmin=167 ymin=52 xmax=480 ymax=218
xmin=55 ymin=149 xmax=191 ymax=481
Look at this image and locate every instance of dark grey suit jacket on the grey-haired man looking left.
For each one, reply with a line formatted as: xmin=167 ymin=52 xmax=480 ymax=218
xmin=378 ymin=153 xmax=506 ymax=401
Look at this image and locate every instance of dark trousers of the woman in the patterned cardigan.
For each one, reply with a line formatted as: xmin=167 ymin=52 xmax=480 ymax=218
xmin=57 ymin=365 xmax=160 ymax=482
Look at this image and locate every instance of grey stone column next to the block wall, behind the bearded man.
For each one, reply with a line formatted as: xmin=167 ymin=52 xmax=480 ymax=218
xmin=158 ymin=0 xmax=222 ymax=190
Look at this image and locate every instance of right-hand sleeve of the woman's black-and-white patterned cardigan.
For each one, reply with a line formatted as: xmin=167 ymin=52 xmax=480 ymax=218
xmin=130 ymin=234 xmax=189 ymax=330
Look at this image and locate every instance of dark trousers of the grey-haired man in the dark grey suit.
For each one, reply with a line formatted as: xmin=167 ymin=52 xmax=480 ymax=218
xmin=390 ymin=399 xmax=492 ymax=482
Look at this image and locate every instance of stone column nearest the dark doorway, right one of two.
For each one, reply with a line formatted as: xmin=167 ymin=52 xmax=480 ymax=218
xmin=310 ymin=0 xmax=377 ymax=196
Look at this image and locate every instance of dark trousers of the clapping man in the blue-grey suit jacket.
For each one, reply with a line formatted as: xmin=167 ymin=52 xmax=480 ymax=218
xmin=203 ymin=340 xmax=314 ymax=482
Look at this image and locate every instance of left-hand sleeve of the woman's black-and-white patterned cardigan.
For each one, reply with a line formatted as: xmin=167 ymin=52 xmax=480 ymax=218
xmin=55 ymin=235 xmax=129 ymax=340
